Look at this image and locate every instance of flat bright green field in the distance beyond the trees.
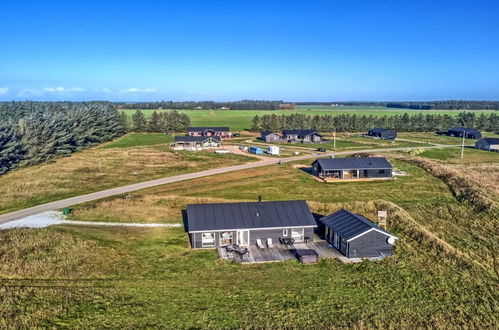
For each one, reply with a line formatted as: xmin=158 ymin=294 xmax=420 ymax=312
xmin=121 ymin=106 xmax=492 ymax=131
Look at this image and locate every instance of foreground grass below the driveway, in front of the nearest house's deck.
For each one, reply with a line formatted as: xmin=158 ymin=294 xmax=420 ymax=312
xmin=0 ymin=204 xmax=499 ymax=329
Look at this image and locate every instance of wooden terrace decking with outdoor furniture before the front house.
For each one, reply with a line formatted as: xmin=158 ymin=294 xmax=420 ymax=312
xmin=218 ymin=241 xmax=356 ymax=263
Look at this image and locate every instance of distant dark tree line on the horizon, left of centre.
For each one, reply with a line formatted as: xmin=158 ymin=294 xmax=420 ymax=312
xmin=117 ymin=100 xmax=283 ymax=110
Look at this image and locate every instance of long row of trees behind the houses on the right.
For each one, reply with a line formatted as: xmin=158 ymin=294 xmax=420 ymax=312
xmin=251 ymin=112 xmax=499 ymax=132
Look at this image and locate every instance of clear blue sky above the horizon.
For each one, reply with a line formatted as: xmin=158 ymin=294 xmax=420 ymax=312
xmin=0 ymin=0 xmax=499 ymax=101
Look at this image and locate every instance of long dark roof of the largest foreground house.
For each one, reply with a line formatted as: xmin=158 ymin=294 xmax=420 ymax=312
xmin=187 ymin=200 xmax=317 ymax=232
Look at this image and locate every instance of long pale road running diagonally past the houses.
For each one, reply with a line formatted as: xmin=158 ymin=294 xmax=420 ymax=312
xmin=0 ymin=145 xmax=456 ymax=224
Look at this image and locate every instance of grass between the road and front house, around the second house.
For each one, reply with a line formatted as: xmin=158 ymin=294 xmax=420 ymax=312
xmin=72 ymin=161 xmax=454 ymax=223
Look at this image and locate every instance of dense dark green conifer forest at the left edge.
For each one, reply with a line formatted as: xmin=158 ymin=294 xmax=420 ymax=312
xmin=0 ymin=102 xmax=126 ymax=174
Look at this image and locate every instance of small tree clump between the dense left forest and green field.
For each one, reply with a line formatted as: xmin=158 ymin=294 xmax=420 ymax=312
xmin=127 ymin=110 xmax=191 ymax=134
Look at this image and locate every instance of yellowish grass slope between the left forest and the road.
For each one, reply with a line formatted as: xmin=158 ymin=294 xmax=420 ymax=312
xmin=0 ymin=139 xmax=256 ymax=213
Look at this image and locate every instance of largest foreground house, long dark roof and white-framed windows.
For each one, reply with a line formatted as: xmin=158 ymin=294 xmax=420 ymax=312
xmin=186 ymin=200 xmax=317 ymax=249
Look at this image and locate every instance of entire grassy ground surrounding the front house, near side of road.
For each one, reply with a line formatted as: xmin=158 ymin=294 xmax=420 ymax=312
xmin=0 ymin=149 xmax=499 ymax=329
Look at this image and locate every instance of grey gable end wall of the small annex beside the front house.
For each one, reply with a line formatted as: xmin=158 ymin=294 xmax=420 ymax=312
xmin=346 ymin=230 xmax=393 ymax=258
